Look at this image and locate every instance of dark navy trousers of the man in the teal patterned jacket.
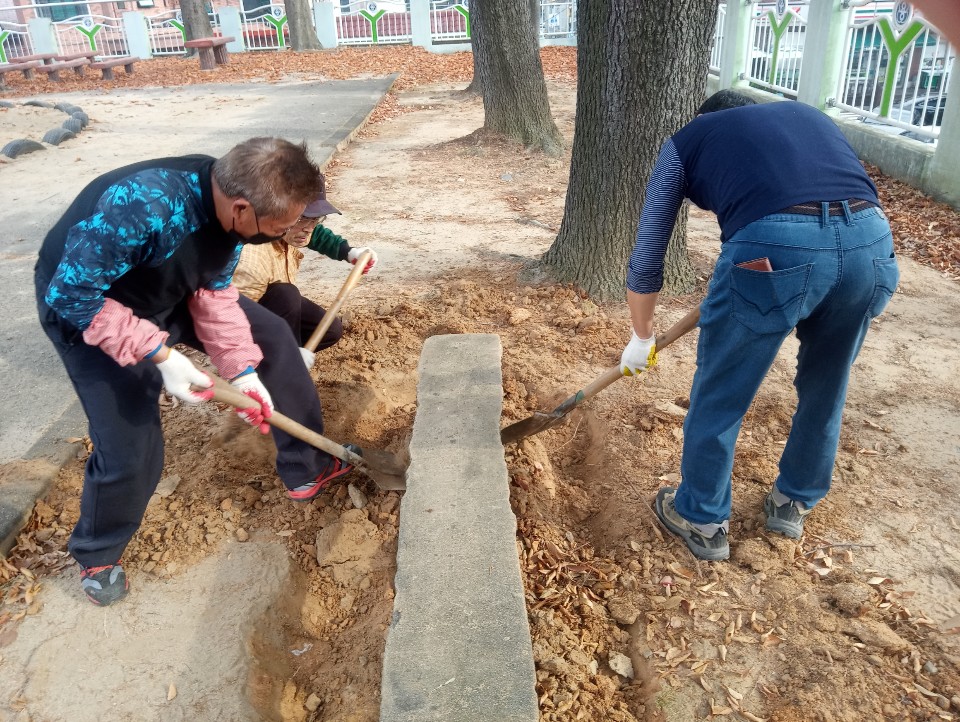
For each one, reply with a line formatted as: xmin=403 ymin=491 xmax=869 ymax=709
xmin=37 ymin=279 xmax=332 ymax=567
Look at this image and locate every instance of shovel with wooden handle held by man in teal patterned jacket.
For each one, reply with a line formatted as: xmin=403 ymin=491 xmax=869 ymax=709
xmin=205 ymin=374 xmax=407 ymax=491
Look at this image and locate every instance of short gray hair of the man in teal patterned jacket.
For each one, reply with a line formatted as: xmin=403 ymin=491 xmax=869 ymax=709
xmin=213 ymin=138 xmax=323 ymax=218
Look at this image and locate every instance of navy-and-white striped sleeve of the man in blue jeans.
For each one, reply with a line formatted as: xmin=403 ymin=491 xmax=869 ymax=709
xmin=627 ymin=140 xmax=685 ymax=293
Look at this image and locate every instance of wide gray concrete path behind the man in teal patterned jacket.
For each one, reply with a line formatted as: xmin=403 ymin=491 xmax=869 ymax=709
xmin=0 ymin=76 xmax=395 ymax=551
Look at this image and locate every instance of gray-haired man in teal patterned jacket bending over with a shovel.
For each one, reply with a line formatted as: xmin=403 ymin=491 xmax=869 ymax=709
xmin=35 ymin=138 xmax=350 ymax=605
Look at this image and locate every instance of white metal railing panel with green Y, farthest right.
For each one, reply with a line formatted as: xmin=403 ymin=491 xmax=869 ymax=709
xmin=834 ymin=0 xmax=956 ymax=140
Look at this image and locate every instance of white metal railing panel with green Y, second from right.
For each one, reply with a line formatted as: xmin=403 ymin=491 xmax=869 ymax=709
xmin=746 ymin=0 xmax=810 ymax=98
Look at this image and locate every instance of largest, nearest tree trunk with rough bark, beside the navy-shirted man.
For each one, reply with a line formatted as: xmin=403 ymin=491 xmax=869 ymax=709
xmin=543 ymin=0 xmax=717 ymax=300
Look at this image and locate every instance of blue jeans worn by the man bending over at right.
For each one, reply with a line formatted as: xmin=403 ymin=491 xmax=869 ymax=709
xmin=675 ymin=203 xmax=899 ymax=524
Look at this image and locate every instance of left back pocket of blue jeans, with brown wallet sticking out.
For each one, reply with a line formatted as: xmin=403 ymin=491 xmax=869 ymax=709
xmin=730 ymin=264 xmax=813 ymax=334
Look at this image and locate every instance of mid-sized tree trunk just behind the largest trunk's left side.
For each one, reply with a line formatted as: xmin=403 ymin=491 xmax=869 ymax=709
xmin=470 ymin=0 xmax=563 ymax=155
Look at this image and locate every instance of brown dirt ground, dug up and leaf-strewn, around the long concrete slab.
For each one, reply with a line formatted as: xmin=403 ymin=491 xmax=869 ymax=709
xmin=0 ymin=70 xmax=960 ymax=722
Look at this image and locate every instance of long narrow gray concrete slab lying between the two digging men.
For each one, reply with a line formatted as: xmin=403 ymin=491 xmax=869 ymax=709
xmin=380 ymin=334 xmax=539 ymax=722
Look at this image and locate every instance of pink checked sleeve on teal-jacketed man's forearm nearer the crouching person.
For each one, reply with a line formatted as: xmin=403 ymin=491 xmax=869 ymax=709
xmin=188 ymin=285 xmax=263 ymax=379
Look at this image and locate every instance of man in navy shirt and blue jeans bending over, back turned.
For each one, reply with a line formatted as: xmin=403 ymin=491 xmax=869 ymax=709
xmin=621 ymin=90 xmax=899 ymax=561
